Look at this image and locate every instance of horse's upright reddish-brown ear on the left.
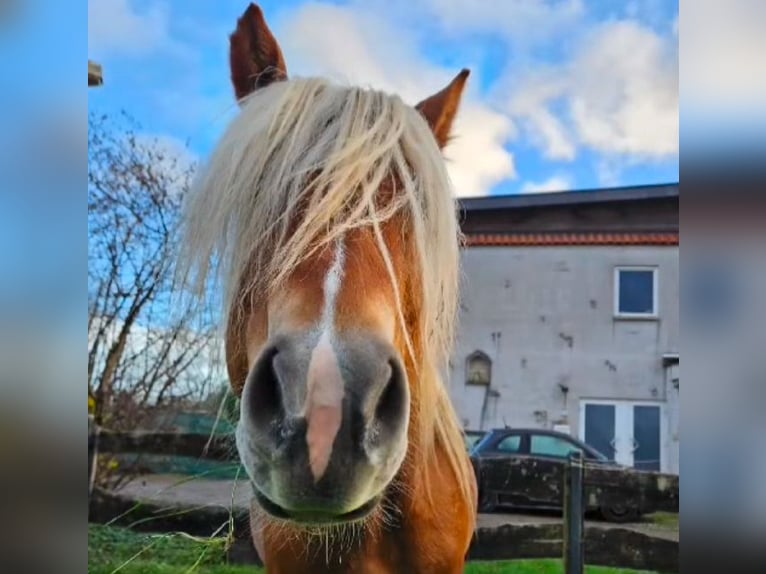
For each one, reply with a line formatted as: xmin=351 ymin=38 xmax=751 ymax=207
xmin=229 ymin=4 xmax=287 ymax=100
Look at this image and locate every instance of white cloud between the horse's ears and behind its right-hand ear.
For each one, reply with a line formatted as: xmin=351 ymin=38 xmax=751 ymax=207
xmin=275 ymin=4 xmax=516 ymax=196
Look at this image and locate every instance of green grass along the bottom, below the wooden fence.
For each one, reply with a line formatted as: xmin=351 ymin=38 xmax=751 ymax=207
xmin=88 ymin=524 xmax=656 ymax=574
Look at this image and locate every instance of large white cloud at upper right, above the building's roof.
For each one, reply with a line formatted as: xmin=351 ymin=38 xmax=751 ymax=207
xmin=502 ymin=21 xmax=679 ymax=160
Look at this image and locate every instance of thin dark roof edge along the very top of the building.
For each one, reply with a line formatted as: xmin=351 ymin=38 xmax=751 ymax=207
xmin=458 ymin=183 xmax=679 ymax=211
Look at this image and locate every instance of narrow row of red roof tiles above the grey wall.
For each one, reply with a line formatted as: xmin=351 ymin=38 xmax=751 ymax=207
xmin=465 ymin=232 xmax=679 ymax=247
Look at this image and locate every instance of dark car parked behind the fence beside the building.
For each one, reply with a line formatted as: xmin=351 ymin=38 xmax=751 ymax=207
xmin=470 ymin=428 xmax=642 ymax=522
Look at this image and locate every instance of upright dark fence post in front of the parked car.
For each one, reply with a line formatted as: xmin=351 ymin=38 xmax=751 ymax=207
xmin=564 ymin=451 xmax=585 ymax=574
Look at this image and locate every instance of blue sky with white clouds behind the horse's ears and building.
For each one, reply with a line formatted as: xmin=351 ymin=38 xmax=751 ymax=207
xmin=88 ymin=0 xmax=679 ymax=196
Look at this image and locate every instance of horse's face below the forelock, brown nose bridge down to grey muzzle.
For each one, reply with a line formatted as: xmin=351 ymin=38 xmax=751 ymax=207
xmin=237 ymin=227 xmax=410 ymax=523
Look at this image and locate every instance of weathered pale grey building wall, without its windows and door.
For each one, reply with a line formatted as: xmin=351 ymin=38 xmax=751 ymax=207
xmin=450 ymin=246 xmax=679 ymax=471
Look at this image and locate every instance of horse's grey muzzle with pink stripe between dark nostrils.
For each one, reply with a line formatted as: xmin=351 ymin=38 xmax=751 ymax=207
xmin=237 ymin=334 xmax=410 ymax=523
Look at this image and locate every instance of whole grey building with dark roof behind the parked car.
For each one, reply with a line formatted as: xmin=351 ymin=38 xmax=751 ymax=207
xmin=450 ymin=185 xmax=679 ymax=473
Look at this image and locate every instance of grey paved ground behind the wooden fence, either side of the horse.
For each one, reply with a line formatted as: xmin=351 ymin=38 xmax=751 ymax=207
xmin=120 ymin=475 xmax=679 ymax=540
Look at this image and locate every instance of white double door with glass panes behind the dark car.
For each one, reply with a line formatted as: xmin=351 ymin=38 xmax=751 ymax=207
xmin=580 ymin=400 xmax=665 ymax=471
